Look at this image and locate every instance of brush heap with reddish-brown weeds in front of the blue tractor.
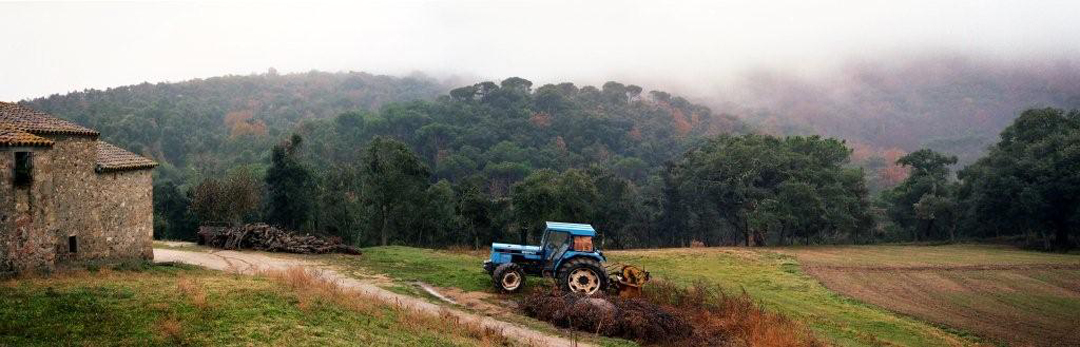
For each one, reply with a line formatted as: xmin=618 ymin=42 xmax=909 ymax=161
xmin=521 ymin=280 xmax=826 ymax=347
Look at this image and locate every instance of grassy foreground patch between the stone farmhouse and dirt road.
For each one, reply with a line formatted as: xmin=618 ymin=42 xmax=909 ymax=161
xmin=0 ymin=260 xmax=512 ymax=346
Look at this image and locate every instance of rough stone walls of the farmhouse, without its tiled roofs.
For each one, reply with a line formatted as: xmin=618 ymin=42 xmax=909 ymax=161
xmin=0 ymin=136 xmax=153 ymax=272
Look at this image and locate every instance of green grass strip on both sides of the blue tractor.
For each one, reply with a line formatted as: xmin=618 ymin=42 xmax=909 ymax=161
xmin=342 ymin=246 xmax=989 ymax=346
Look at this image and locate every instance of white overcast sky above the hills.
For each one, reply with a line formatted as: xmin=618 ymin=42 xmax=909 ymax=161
xmin=0 ymin=0 xmax=1080 ymax=101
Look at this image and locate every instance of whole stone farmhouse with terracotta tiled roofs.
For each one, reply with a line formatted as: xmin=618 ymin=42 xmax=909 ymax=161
xmin=0 ymin=102 xmax=157 ymax=273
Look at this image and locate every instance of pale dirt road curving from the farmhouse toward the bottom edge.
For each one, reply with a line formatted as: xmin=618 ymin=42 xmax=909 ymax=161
xmin=153 ymin=249 xmax=589 ymax=346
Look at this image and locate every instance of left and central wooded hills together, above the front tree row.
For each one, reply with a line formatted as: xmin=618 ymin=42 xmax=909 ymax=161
xmin=24 ymin=71 xmax=746 ymax=183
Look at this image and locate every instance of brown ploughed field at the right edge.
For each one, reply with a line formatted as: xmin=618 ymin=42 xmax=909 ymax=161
xmin=780 ymin=245 xmax=1080 ymax=346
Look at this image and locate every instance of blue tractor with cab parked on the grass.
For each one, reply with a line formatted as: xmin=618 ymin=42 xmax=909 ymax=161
xmin=484 ymin=222 xmax=609 ymax=295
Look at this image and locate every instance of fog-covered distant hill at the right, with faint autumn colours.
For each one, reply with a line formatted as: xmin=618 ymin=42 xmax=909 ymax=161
xmin=717 ymin=55 xmax=1080 ymax=163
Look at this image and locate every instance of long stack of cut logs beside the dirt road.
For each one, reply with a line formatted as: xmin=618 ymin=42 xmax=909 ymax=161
xmin=199 ymin=223 xmax=361 ymax=255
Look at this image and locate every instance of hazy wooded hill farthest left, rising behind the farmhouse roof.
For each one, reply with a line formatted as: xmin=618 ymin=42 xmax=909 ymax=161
xmin=24 ymin=69 xmax=448 ymax=177
